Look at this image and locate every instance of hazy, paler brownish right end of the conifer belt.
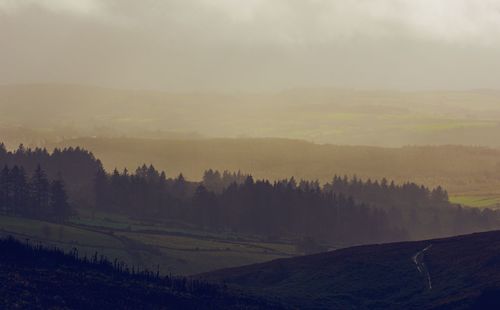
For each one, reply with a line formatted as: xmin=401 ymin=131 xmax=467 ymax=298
xmin=323 ymin=176 xmax=500 ymax=239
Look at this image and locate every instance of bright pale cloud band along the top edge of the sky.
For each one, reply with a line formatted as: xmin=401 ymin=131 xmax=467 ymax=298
xmin=0 ymin=0 xmax=500 ymax=44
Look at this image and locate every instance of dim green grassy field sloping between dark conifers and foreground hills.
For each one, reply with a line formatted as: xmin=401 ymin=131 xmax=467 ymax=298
xmin=0 ymin=214 xmax=295 ymax=275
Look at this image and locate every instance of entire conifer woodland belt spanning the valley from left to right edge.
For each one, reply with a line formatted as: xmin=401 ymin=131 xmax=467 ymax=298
xmin=0 ymin=146 xmax=500 ymax=246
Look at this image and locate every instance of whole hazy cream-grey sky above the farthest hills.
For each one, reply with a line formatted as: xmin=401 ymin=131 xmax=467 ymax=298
xmin=0 ymin=0 xmax=500 ymax=91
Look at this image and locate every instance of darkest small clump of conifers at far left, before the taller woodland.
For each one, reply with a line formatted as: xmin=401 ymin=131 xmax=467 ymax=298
xmin=0 ymin=166 xmax=71 ymax=221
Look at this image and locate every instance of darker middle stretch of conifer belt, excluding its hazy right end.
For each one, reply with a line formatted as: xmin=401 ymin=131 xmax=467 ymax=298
xmin=95 ymin=166 xmax=406 ymax=244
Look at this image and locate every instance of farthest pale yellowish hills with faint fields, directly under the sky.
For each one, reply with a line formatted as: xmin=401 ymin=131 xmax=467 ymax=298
xmin=0 ymin=84 xmax=500 ymax=147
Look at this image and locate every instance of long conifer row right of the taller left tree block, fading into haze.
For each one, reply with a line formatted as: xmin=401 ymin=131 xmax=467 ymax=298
xmin=95 ymin=166 xmax=500 ymax=244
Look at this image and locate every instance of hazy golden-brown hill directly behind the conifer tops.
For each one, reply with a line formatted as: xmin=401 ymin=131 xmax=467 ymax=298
xmin=49 ymin=138 xmax=500 ymax=194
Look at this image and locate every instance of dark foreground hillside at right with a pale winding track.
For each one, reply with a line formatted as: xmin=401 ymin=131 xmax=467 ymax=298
xmin=200 ymin=231 xmax=500 ymax=309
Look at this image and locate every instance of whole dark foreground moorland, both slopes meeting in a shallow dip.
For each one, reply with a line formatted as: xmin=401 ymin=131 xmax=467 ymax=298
xmin=0 ymin=226 xmax=500 ymax=309
